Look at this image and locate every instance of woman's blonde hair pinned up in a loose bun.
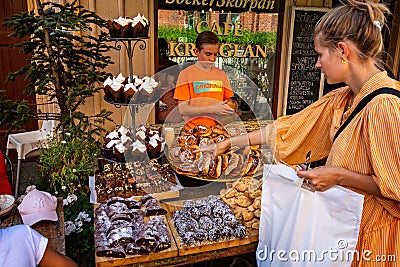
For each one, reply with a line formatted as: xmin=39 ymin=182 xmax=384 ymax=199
xmin=314 ymin=0 xmax=390 ymax=69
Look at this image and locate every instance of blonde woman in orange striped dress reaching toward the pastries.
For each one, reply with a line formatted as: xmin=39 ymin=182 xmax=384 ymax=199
xmin=205 ymin=0 xmax=400 ymax=266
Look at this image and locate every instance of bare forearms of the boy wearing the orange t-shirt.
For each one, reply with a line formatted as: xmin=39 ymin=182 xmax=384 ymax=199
xmin=178 ymin=100 xmax=235 ymax=116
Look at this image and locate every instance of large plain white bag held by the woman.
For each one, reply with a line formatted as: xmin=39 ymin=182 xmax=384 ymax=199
xmin=256 ymin=164 xmax=364 ymax=267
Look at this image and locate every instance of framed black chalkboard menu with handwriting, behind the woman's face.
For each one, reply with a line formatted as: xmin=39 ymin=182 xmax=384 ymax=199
xmin=284 ymin=7 xmax=328 ymax=115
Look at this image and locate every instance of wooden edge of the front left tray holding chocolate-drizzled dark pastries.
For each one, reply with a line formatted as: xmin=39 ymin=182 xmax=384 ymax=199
xmin=94 ymin=213 xmax=178 ymax=267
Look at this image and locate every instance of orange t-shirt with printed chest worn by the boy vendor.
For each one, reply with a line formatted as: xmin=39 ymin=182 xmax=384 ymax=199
xmin=174 ymin=64 xmax=233 ymax=129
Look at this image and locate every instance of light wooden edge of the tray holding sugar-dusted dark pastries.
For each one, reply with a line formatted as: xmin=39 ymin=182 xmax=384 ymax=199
xmin=161 ymin=200 xmax=258 ymax=256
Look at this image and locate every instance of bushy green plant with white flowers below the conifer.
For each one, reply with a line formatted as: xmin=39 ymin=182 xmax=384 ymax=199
xmin=38 ymin=131 xmax=100 ymax=266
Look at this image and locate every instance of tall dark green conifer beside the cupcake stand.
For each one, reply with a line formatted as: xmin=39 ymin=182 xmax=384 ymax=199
xmin=0 ymin=0 xmax=114 ymax=133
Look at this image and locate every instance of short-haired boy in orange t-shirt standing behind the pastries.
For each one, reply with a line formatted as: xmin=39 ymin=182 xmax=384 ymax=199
xmin=174 ymin=31 xmax=235 ymax=130
